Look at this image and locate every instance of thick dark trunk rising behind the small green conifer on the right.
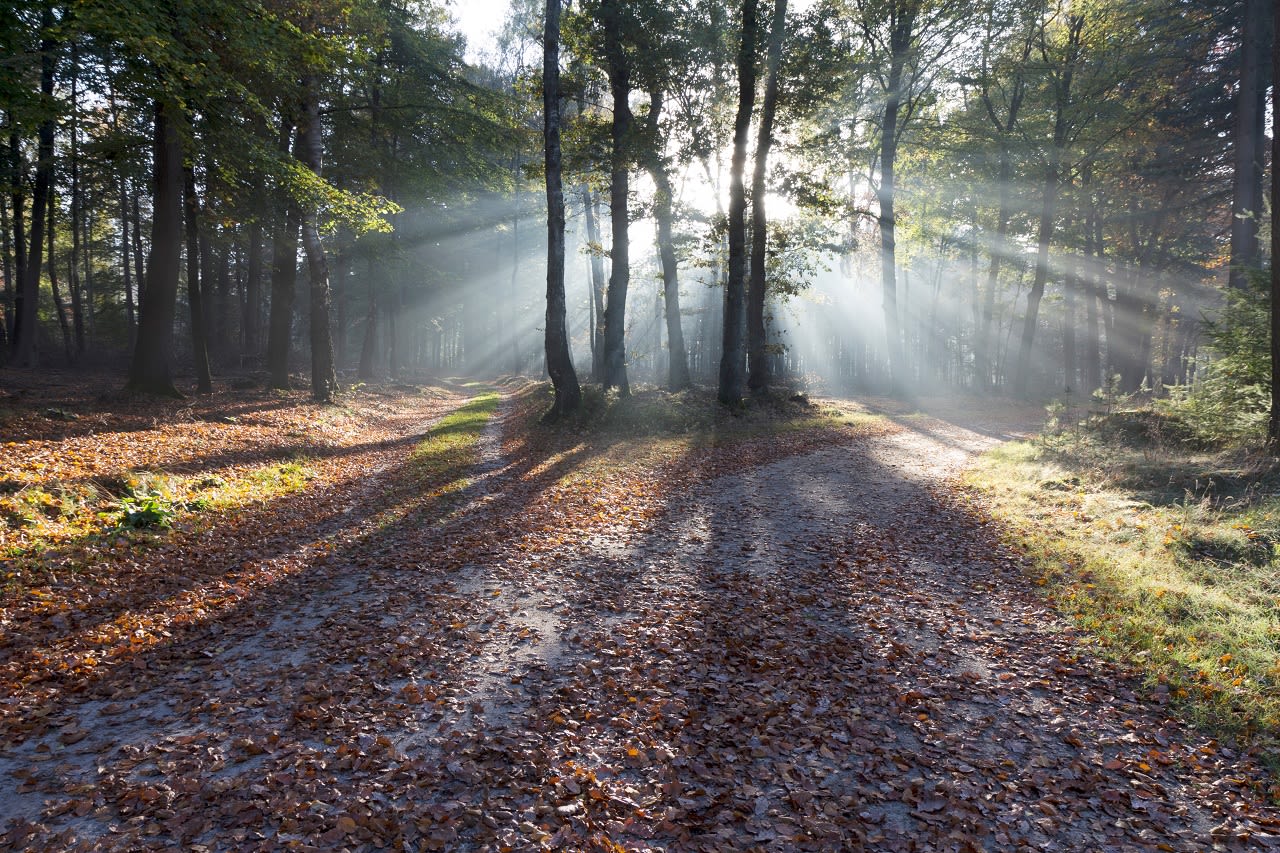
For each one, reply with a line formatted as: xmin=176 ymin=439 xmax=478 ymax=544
xmin=1228 ymin=0 xmax=1275 ymax=288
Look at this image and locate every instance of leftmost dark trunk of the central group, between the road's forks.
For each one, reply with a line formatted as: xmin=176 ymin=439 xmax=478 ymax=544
xmin=543 ymin=0 xmax=582 ymax=418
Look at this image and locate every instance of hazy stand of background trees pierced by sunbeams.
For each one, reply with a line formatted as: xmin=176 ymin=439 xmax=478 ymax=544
xmin=0 ymin=0 xmax=1274 ymax=427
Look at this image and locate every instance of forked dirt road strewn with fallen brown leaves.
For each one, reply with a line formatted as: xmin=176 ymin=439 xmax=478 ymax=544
xmin=0 ymin=394 xmax=1280 ymax=852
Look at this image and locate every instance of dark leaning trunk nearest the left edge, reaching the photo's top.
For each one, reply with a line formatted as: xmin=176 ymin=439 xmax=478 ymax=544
xmin=10 ymin=3 xmax=56 ymax=368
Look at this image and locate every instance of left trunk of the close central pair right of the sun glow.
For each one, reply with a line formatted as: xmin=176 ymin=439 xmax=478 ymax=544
xmin=717 ymin=0 xmax=758 ymax=406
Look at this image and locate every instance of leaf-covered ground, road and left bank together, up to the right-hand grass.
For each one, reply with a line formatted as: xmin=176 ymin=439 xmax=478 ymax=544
xmin=0 ymin=386 xmax=1280 ymax=850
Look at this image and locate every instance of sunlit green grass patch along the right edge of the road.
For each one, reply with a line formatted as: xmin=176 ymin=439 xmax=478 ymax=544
xmin=966 ymin=410 xmax=1280 ymax=757
